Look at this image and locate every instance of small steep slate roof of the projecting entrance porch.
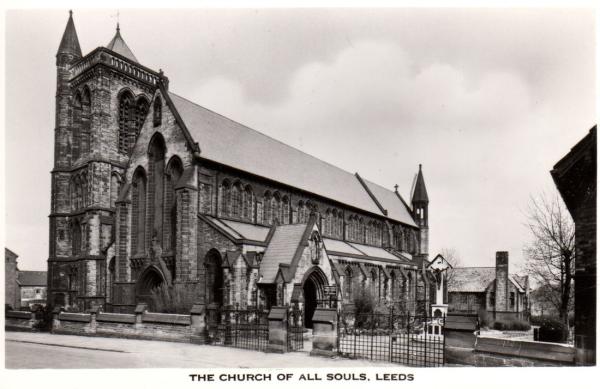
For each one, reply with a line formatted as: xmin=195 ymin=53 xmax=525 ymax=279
xmin=260 ymin=224 xmax=307 ymax=284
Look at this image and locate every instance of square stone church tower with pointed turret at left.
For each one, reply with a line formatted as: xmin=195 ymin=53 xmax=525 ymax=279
xmin=48 ymin=11 xmax=160 ymax=309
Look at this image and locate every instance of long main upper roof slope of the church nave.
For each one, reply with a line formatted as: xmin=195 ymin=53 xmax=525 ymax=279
xmin=168 ymin=92 xmax=416 ymax=226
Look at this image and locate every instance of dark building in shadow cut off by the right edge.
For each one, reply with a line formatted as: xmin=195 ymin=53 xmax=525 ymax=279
xmin=551 ymin=126 xmax=597 ymax=365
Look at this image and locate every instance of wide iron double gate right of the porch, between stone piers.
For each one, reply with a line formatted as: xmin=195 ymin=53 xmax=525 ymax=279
xmin=338 ymin=310 xmax=445 ymax=367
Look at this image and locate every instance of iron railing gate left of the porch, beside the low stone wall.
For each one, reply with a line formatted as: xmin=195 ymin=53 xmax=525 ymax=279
xmin=207 ymin=307 xmax=269 ymax=351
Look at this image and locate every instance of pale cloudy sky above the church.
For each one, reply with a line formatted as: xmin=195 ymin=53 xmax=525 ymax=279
xmin=4 ymin=8 xmax=596 ymax=271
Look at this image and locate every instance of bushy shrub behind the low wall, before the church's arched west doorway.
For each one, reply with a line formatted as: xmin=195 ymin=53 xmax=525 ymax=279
xmin=148 ymin=283 xmax=197 ymax=314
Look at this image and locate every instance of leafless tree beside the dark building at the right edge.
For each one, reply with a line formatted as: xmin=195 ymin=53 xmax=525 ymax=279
xmin=524 ymin=194 xmax=575 ymax=323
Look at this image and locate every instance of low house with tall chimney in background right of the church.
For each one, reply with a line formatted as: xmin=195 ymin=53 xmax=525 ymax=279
xmin=448 ymin=251 xmax=529 ymax=320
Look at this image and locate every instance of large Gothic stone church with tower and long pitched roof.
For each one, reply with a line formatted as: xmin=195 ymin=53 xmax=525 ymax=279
xmin=48 ymin=13 xmax=436 ymax=322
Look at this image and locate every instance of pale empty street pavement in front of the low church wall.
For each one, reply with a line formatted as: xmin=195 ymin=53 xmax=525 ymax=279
xmin=5 ymin=332 xmax=399 ymax=369
